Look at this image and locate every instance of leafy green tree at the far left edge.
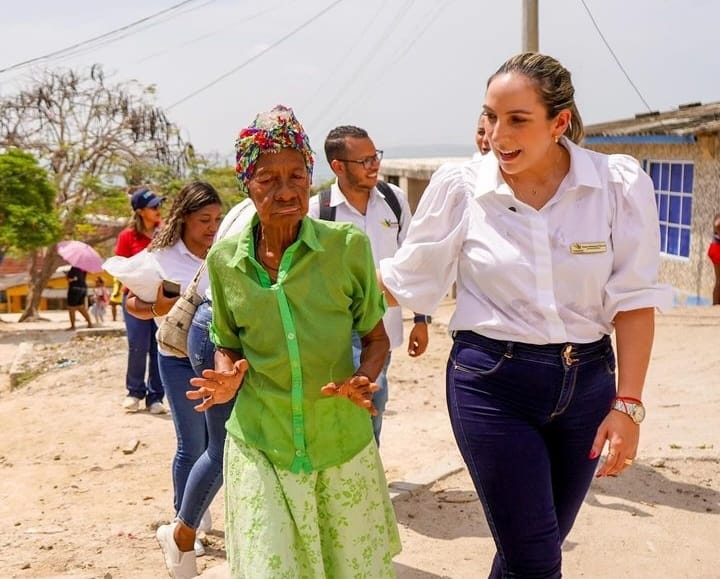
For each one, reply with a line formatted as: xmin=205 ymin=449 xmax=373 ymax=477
xmin=0 ymin=149 xmax=60 ymax=261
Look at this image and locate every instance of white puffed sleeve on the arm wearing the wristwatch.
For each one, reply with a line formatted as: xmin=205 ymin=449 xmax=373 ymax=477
xmin=604 ymin=155 xmax=673 ymax=320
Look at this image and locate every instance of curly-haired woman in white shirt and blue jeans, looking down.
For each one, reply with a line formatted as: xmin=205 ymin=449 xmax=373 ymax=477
xmin=126 ymin=181 xmax=222 ymax=579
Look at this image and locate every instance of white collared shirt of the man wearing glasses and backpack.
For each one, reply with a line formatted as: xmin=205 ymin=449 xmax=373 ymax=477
xmin=308 ymin=180 xmax=410 ymax=350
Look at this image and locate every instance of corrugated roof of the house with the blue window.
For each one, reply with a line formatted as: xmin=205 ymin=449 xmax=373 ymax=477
xmin=585 ymin=102 xmax=720 ymax=137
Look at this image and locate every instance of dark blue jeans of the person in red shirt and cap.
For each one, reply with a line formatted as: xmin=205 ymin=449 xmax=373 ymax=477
xmin=122 ymin=294 xmax=165 ymax=408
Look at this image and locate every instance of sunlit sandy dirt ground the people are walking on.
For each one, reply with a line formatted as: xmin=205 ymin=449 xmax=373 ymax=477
xmin=0 ymin=305 xmax=720 ymax=579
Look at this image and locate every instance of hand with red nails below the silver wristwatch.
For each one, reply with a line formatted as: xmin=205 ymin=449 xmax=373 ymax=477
xmin=590 ymin=410 xmax=640 ymax=477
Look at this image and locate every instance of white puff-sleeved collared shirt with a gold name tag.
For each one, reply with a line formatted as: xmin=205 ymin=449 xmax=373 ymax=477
xmin=380 ymin=138 xmax=672 ymax=344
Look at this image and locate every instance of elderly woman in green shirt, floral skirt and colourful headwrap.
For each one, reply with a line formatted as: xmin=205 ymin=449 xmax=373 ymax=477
xmin=188 ymin=106 xmax=400 ymax=579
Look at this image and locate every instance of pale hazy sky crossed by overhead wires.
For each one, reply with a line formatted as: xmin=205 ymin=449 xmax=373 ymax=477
xmin=0 ymin=0 xmax=720 ymax=157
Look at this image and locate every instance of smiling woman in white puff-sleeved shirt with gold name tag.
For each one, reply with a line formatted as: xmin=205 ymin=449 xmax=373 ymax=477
xmin=380 ymin=53 xmax=672 ymax=578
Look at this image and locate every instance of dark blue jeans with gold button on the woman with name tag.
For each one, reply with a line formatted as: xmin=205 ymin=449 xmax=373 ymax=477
xmin=447 ymin=332 xmax=615 ymax=579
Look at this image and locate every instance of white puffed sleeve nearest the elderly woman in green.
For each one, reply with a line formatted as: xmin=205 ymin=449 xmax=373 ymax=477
xmin=380 ymin=165 xmax=472 ymax=313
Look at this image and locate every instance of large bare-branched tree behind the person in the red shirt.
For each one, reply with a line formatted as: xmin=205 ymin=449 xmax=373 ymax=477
xmin=0 ymin=65 xmax=185 ymax=321
